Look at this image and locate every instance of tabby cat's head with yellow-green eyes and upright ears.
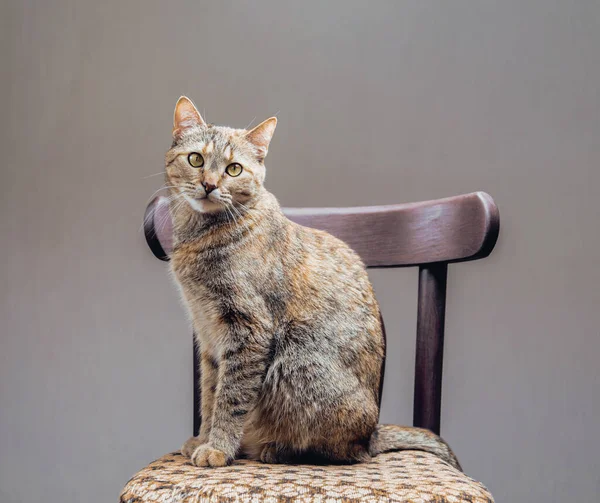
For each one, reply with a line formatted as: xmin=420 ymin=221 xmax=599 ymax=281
xmin=165 ymin=96 xmax=277 ymax=213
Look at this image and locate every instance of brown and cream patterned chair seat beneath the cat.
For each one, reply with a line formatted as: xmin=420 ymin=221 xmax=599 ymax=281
xmin=121 ymin=451 xmax=494 ymax=503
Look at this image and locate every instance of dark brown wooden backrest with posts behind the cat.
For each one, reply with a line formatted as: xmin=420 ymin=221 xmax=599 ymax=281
xmin=144 ymin=192 xmax=500 ymax=434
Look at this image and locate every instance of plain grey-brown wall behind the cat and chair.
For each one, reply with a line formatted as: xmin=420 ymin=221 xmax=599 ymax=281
xmin=0 ymin=0 xmax=600 ymax=503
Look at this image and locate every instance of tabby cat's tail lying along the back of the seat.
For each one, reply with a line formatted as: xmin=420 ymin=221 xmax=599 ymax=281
xmin=369 ymin=424 xmax=462 ymax=472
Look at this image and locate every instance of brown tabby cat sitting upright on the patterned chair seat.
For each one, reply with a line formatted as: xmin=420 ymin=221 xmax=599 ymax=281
xmin=165 ymin=96 xmax=460 ymax=469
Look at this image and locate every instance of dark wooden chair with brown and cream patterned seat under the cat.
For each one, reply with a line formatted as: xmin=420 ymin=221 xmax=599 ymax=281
xmin=121 ymin=192 xmax=499 ymax=503
